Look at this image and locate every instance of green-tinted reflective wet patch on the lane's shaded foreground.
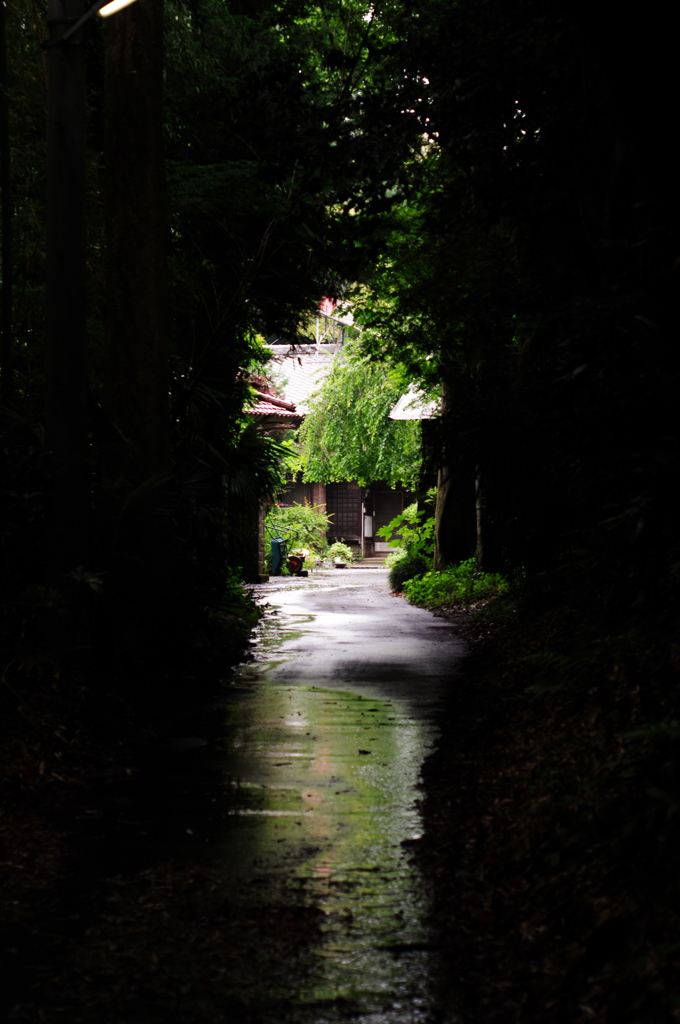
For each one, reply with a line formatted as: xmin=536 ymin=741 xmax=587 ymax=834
xmin=214 ymin=593 xmax=446 ymax=1024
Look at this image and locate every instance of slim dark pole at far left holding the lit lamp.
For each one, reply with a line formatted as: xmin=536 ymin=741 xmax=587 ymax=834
xmin=45 ymin=0 xmax=90 ymax=582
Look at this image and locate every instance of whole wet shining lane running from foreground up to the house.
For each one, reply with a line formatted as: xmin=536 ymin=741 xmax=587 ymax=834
xmin=218 ymin=568 xmax=463 ymax=1024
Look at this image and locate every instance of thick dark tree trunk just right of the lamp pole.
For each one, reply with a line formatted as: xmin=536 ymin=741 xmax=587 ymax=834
xmin=102 ymin=0 xmax=175 ymax=657
